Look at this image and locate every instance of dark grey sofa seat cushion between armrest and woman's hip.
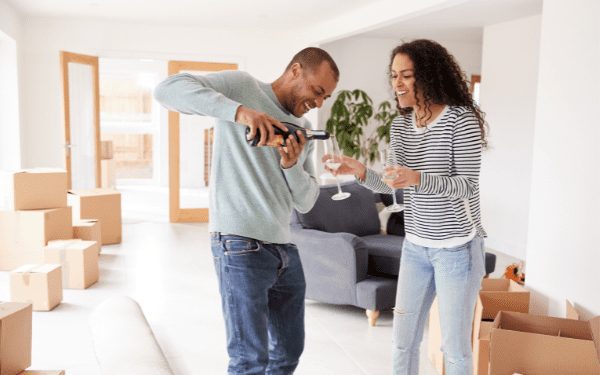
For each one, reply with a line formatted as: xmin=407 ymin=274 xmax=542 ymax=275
xmin=361 ymin=234 xmax=404 ymax=276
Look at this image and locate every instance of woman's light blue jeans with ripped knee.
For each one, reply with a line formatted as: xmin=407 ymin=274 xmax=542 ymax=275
xmin=393 ymin=237 xmax=485 ymax=375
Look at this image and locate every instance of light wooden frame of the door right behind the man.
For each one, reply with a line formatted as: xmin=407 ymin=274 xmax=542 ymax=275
xmin=168 ymin=61 xmax=238 ymax=223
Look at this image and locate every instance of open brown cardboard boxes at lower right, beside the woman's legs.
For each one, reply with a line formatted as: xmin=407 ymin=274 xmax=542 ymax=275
xmin=428 ymin=279 xmax=600 ymax=375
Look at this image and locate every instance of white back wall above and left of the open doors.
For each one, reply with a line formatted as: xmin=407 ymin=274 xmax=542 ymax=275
xmin=21 ymin=17 xmax=305 ymax=167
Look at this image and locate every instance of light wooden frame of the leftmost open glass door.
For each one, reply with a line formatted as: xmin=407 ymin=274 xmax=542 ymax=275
xmin=60 ymin=51 xmax=101 ymax=189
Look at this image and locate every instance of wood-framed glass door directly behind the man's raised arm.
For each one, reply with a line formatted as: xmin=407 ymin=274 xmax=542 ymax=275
xmin=168 ymin=61 xmax=238 ymax=222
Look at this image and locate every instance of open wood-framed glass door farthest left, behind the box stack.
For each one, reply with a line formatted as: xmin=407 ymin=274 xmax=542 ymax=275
xmin=60 ymin=51 xmax=101 ymax=189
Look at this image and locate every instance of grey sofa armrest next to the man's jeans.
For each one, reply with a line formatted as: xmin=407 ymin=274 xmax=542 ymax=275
xmin=291 ymin=227 xmax=368 ymax=304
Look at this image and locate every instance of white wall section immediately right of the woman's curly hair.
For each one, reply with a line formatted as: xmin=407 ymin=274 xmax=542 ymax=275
xmin=480 ymin=16 xmax=542 ymax=260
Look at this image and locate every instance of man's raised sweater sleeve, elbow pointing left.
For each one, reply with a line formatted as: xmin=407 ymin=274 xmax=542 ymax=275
xmin=154 ymin=72 xmax=240 ymax=122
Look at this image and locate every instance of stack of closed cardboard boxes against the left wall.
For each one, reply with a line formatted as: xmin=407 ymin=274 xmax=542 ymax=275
xmin=0 ymin=169 xmax=121 ymax=311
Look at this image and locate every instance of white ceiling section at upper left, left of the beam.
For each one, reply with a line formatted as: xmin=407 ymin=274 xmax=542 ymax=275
xmin=5 ymin=0 xmax=373 ymax=30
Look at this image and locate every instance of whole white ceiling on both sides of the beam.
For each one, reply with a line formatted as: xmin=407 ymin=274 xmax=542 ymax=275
xmin=7 ymin=0 xmax=543 ymax=42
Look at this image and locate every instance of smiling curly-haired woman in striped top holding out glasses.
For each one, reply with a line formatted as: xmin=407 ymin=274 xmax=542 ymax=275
xmin=324 ymin=40 xmax=486 ymax=375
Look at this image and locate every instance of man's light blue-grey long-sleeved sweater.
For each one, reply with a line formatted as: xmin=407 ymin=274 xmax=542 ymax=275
xmin=154 ymin=71 xmax=319 ymax=243
